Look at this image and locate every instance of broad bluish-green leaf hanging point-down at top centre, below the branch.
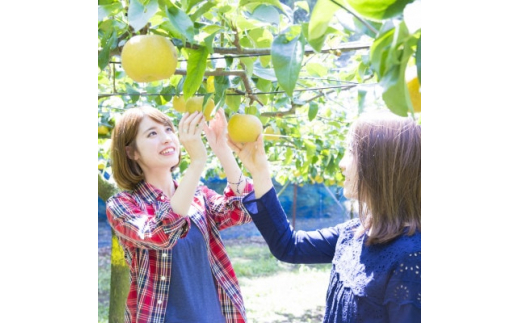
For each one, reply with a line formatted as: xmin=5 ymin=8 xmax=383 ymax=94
xmin=271 ymin=26 xmax=304 ymax=97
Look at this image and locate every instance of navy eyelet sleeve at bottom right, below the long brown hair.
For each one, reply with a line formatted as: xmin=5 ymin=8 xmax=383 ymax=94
xmin=384 ymin=251 xmax=421 ymax=322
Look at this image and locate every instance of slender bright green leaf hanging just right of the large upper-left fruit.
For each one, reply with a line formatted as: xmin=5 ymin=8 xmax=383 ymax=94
xmin=184 ymin=46 xmax=209 ymax=100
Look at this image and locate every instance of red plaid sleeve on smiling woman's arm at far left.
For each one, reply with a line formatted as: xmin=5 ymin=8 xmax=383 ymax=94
xmin=106 ymin=192 xmax=191 ymax=250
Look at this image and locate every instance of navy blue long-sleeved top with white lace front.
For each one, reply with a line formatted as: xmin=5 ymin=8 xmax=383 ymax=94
xmin=243 ymin=188 xmax=421 ymax=323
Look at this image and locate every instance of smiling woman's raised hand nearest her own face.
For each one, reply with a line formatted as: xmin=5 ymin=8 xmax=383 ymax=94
xmin=178 ymin=111 xmax=208 ymax=164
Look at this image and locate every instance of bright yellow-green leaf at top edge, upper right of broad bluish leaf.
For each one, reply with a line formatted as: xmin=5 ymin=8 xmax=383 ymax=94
xmin=307 ymin=0 xmax=340 ymax=52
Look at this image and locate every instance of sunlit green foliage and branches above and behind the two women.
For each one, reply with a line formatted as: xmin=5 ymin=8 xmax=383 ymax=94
xmin=98 ymin=0 xmax=421 ymax=185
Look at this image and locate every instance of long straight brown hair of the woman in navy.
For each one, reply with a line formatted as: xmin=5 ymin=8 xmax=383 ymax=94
xmin=349 ymin=111 xmax=421 ymax=245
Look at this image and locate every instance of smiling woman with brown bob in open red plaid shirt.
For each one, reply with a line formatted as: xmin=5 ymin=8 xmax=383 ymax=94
xmin=107 ymin=106 xmax=252 ymax=323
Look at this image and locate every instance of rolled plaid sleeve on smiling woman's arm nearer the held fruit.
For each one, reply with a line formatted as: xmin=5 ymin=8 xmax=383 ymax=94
xmin=204 ymin=177 xmax=253 ymax=230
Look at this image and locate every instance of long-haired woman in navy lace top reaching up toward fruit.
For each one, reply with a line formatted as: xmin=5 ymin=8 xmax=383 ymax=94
xmin=228 ymin=113 xmax=421 ymax=323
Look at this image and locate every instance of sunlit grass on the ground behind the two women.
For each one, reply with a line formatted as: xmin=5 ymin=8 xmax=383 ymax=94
xmin=98 ymin=237 xmax=331 ymax=323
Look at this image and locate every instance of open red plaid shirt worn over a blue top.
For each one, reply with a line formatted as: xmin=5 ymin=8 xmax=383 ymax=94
xmin=107 ymin=179 xmax=253 ymax=323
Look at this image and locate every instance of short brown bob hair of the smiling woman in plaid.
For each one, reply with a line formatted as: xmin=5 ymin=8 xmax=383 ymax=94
xmin=110 ymin=106 xmax=180 ymax=191
